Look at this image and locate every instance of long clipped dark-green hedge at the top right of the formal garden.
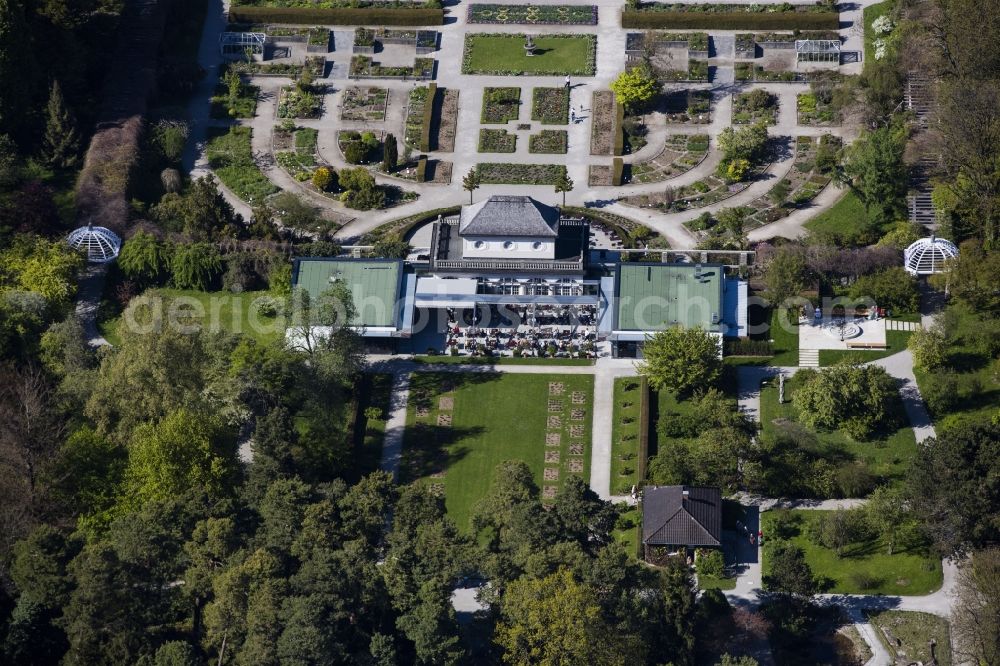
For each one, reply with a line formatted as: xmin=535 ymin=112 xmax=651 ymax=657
xmin=622 ymin=10 xmax=840 ymax=30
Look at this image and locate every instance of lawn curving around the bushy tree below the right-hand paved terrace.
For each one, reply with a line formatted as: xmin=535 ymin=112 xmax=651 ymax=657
xmin=760 ymin=370 xmax=917 ymax=484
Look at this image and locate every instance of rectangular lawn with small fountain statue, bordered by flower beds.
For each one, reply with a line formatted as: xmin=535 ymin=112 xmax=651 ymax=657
xmin=462 ymin=34 xmax=597 ymax=76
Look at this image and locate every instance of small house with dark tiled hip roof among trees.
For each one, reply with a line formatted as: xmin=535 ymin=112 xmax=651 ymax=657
xmin=642 ymin=486 xmax=722 ymax=557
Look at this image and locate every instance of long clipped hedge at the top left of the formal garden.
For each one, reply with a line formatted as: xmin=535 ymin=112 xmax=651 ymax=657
xmin=229 ymin=7 xmax=444 ymax=26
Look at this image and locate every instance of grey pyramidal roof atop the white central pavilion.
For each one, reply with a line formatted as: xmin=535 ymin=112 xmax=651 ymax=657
xmin=458 ymin=195 xmax=559 ymax=238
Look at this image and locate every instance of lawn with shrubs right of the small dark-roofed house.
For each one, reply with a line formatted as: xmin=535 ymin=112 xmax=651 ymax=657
xmin=761 ymin=509 xmax=942 ymax=595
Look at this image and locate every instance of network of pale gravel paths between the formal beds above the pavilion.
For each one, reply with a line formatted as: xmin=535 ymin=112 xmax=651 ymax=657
xmin=184 ymin=0 xmax=872 ymax=247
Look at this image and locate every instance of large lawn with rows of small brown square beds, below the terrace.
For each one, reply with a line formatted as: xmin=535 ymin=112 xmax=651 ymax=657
xmin=402 ymin=372 xmax=594 ymax=530
